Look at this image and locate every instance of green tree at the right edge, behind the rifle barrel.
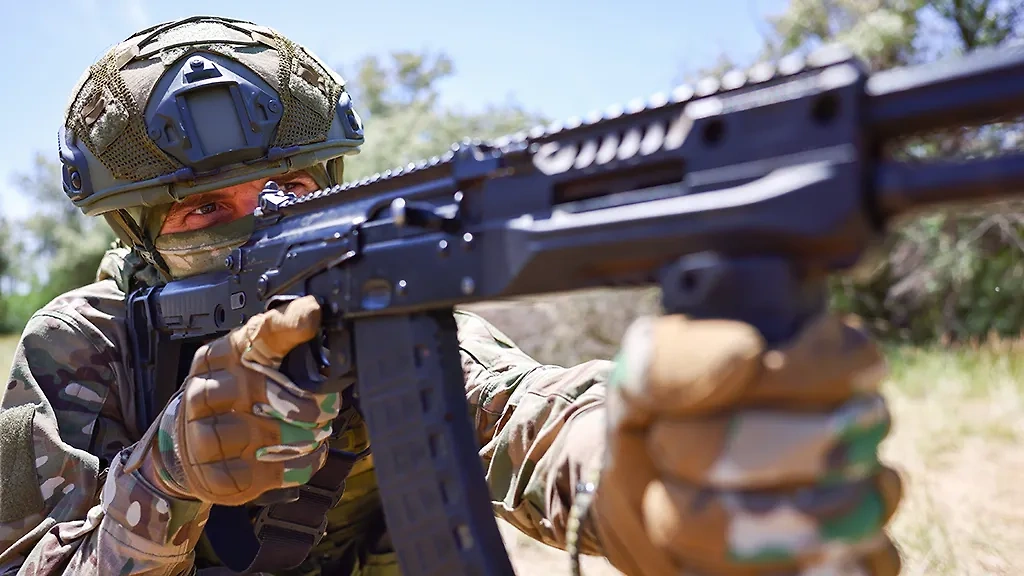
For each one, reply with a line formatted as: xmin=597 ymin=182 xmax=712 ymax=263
xmin=765 ymin=0 xmax=1024 ymax=341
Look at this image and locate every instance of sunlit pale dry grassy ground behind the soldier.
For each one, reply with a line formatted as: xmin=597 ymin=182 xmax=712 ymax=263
xmin=0 ymin=325 xmax=1024 ymax=576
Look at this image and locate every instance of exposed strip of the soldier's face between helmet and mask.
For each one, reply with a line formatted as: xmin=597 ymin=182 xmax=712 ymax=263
xmin=160 ymin=170 xmax=317 ymax=235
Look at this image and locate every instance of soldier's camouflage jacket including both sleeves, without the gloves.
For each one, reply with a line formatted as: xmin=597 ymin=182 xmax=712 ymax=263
xmin=0 ymin=251 xmax=610 ymax=576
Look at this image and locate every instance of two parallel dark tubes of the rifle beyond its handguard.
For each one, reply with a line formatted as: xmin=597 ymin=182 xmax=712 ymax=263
xmin=865 ymin=44 xmax=1024 ymax=219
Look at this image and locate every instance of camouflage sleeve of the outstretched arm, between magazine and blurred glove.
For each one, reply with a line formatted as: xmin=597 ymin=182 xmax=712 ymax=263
xmin=456 ymin=311 xmax=612 ymax=554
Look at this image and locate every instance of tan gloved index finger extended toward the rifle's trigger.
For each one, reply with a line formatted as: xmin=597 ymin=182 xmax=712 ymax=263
xmin=238 ymin=296 xmax=321 ymax=368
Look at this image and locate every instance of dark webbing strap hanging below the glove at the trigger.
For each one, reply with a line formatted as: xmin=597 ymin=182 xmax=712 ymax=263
xmin=205 ymin=449 xmax=359 ymax=574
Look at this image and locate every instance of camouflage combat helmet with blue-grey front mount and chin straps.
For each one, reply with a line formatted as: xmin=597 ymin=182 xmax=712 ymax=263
xmin=58 ymin=16 xmax=364 ymax=279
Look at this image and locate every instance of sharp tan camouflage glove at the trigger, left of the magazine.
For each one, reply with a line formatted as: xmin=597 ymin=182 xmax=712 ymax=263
xmin=126 ymin=296 xmax=341 ymax=505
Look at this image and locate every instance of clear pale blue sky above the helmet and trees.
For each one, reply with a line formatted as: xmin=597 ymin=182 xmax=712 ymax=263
xmin=0 ymin=0 xmax=785 ymax=217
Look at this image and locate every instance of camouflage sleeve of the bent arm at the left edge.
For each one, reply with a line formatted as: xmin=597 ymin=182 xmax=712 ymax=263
xmin=0 ymin=305 xmax=208 ymax=576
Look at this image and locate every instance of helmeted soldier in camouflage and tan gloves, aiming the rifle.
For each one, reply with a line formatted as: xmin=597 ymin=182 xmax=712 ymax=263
xmin=0 ymin=17 xmax=900 ymax=576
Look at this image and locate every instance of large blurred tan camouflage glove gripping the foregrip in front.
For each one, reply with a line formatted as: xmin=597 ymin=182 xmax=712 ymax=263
xmin=590 ymin=315 xmax=901 ymax=576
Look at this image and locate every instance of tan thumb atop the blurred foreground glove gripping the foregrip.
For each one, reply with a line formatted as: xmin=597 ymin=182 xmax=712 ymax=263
xmin=622 ymin=316 xmax=764 ymax=415
